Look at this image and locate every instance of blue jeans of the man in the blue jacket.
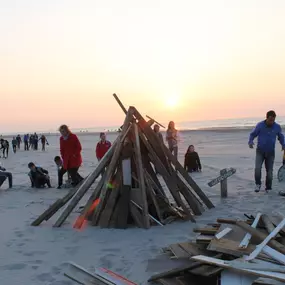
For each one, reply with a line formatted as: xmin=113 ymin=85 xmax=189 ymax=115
xmin=255 ymin=149 xmax=275 ymax=189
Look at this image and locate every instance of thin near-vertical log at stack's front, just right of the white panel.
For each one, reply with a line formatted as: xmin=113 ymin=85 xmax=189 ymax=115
xmin=133 ymin=124 xmax=150 ymax=229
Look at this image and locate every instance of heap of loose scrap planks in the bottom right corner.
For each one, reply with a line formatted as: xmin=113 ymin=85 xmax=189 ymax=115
xmin=149 ymin=213 xmax=285 ymax=285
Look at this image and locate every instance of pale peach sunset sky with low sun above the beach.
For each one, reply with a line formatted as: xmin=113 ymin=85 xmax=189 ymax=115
xmin=0 ymin=0 xmax=285 ymax=132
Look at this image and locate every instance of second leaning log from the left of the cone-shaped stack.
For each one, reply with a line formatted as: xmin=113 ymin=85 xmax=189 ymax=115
xmin=53 ymin=140 xmax=118 ymax=227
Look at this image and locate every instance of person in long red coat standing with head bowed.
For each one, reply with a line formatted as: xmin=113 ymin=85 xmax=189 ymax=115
xmin=59 ymin=125 xmax=83 ymax=186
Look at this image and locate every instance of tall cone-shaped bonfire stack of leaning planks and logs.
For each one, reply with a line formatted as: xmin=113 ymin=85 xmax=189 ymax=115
xmin=32 ymin=94 xmax=214 ymax=228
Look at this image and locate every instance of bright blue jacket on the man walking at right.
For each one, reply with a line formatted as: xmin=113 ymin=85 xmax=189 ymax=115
xmin=248 ymin=121 xmax=285 ymax=152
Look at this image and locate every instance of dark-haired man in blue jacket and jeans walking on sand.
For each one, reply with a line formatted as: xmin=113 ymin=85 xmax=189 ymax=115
xmin=248 ymin=111 xmax=285 ymax=192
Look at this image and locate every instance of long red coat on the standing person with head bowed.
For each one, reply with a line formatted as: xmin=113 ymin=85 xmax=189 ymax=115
xmin=60 ymin=133 xmax=82 ymax=169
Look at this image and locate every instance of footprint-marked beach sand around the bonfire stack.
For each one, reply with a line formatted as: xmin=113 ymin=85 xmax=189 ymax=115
xmin=0 ymin=130 xmax=285 ymax=285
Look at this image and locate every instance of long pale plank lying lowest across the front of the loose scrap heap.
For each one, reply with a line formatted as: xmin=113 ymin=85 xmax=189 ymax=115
xmin=191 ymin=255 xmax=285 ymax=282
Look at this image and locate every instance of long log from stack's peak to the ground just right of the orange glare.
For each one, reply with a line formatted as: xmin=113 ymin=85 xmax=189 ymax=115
xmin=92 ymin=109 xmax=133 ymax=225
